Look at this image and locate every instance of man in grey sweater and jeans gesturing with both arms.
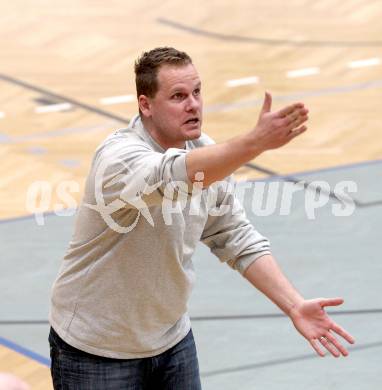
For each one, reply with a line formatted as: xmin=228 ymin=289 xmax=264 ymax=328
xmin=49 ymin=47 xmax=354 ymax=390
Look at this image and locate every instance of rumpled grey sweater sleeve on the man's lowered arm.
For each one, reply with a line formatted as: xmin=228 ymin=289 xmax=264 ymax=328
xmin=201 ymin=178 xmax=271 ymax=274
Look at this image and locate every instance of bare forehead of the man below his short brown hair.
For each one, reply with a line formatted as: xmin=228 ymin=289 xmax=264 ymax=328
xmin=157 ymin=64 xmax=200 ymax=91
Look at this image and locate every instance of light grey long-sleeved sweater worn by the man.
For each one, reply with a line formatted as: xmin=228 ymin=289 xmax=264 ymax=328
xmin=50 ymin=116 xmax=270 ymax=359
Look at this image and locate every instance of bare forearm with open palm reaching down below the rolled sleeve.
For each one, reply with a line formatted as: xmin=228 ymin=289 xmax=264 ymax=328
xmin=244 ymin=255 xmax=354 ymax=357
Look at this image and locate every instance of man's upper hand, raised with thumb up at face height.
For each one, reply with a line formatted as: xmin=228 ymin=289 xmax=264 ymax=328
xmin=253 ymin=92 xmax=309 ymax=151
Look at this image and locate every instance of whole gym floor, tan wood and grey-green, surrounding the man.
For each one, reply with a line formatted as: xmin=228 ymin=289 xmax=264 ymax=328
xmin=0 ymin=0 xmax=382 ymax=390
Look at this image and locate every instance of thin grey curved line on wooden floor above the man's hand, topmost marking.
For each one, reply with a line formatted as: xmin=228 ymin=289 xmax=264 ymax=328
xmin=156 ymin=18 xmax=382 ymax=47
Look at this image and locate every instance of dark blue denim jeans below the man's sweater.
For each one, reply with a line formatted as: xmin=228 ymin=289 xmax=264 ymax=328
xmin=49 ymin=328 xmax=201 ymax=390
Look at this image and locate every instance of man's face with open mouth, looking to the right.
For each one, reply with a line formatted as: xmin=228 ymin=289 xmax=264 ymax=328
xmin=144 ymin=64 xmax=203 ymax=147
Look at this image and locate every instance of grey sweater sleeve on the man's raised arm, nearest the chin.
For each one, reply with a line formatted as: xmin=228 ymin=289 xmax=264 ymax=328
xmin=92 ymin=140 xmax=192 ymax=209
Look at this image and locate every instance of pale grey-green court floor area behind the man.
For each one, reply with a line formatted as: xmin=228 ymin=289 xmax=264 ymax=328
xmin=0 ymin=161 xmax=382 ymax=390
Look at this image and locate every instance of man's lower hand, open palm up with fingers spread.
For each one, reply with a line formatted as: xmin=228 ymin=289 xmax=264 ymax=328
xmin=290 ymin=298 xmax=354 ymax=357
